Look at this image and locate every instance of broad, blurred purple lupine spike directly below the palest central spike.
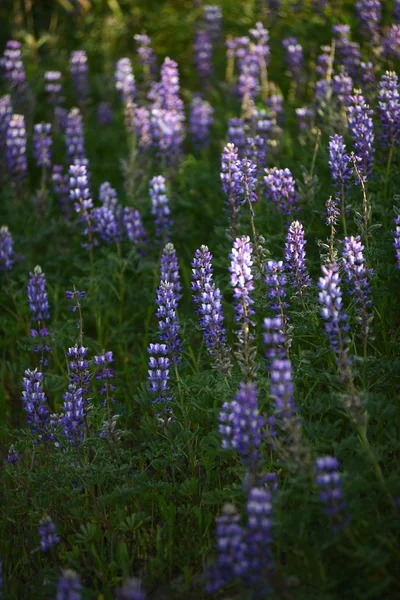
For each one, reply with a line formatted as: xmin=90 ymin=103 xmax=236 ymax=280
xmin=219 ymin=383 xmax=264 ymax=465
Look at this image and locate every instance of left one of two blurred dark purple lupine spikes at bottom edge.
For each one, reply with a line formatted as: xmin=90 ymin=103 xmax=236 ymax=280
xmin=205 ymin=504 xmax=248 ymax=594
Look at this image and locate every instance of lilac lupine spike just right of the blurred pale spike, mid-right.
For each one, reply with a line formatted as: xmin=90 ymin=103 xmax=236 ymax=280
xmin=342 ymin=236 xmax=373 ymax=340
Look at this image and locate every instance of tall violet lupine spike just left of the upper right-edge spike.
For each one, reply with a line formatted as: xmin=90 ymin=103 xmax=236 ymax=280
xmin=347 ymin=92 xmax=375 ymax=180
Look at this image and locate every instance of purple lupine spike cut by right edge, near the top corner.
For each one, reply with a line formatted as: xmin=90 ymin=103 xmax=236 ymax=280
xmin=378 ymin=71 xmax=400 ymax=147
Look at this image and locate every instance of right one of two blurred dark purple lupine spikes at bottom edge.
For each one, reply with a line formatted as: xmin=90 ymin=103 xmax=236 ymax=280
xmin=246 ymin=487 xmax=272 ymax=593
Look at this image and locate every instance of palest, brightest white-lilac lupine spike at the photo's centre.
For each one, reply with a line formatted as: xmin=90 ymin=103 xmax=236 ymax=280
xmin=229 ymin=235 xmax=254 ymax=324
